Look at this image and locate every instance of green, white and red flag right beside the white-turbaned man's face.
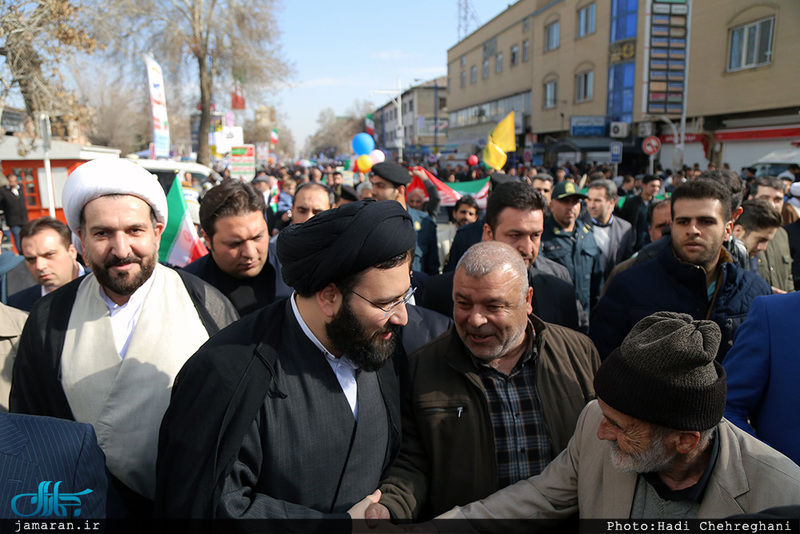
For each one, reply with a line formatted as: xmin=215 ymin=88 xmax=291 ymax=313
xmin=158 ymin=176 xmax=208 ymax=267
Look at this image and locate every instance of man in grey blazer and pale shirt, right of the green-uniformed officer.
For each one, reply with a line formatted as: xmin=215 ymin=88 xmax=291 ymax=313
xmin=586 ymin=179 xmax=636 ymax=279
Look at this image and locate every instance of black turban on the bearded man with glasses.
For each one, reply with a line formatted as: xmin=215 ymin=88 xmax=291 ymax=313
xmin=277 ymin=199 xmax=417 ymax=295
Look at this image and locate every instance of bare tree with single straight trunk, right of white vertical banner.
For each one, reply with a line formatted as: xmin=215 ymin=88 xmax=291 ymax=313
xmin=95 ymin=0 xmax=290 ymax=163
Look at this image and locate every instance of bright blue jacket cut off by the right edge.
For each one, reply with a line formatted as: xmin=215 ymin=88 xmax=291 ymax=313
xmin=722 ymin=293 xmax=800 ymax=463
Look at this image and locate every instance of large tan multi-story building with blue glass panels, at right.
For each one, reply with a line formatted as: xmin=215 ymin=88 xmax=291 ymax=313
xmin=446 ymin=0 xmax=800 ymax=174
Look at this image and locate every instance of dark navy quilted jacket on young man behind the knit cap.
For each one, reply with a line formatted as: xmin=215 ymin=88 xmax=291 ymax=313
xmin=589 ymin=246 xmax=772 ymax=362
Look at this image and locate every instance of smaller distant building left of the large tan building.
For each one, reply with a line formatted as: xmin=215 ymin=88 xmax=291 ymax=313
xmin=373 ymin=76 xmax=448 ymax=161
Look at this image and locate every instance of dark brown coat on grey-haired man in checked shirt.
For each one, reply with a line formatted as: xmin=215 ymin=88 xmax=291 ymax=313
xmin=380 ymin=315 xmax=600 ymax=520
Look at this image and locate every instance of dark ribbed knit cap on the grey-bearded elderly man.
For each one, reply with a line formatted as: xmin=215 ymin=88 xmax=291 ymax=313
xmin=594 ymin=312 xmax=727 ymax=431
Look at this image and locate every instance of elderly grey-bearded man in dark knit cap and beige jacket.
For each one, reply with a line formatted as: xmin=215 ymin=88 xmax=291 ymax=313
xmin=440 ymin=312 xmax=800 ymax=526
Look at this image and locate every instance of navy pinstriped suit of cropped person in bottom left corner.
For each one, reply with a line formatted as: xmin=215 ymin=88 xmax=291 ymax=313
xmin=0 ymin=413 xmax=112 ymax=520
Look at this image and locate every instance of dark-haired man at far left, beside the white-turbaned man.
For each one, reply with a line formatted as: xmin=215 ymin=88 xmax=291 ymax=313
xmin=8 ymin=217 xmax=86 ymax=312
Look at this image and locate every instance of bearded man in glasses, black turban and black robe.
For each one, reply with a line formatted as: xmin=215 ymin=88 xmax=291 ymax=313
xmin=156 ymin=199 xmax=415 ymax=521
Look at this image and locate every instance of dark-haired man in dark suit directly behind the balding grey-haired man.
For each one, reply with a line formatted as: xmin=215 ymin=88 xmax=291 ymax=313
xmin=420 ymin=182 xmax=585 ymax=330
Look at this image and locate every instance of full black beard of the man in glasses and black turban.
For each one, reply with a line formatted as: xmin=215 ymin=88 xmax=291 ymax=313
xmin=325 ymin=297 xmax=400 ymax=372
